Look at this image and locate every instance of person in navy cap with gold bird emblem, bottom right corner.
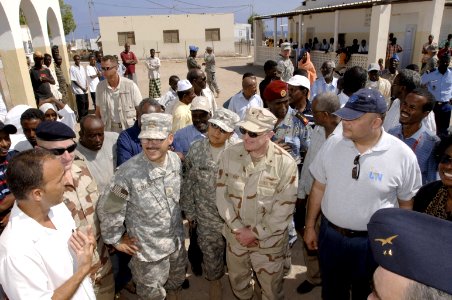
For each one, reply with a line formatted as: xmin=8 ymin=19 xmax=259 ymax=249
xmin=367 ymin=208 xmax=452 ymax=300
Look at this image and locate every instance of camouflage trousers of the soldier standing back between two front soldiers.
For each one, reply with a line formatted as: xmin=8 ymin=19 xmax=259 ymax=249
xmin=197 ymin=225 xmax=225 ymax=281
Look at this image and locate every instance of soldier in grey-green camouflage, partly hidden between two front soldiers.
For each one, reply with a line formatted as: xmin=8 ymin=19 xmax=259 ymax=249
xmin=181 ymin=108 xmax=240 ymax=300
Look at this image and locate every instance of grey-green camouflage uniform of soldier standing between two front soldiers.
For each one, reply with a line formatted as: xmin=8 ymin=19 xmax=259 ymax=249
xmin=181 ymin=138 xmax=236 ymax=281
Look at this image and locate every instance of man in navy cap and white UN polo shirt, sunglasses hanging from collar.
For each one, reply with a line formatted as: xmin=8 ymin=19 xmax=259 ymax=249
xmin=304 ymin=88 xmax=421 ymax=300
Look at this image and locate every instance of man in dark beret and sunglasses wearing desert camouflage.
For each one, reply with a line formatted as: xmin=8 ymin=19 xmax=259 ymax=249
xmin=36 ymin=121 xmax=115 ymax=300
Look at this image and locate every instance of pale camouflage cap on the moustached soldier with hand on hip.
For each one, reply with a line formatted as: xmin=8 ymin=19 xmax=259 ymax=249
xmin=138 ymin=113 xmax=173 ymax=140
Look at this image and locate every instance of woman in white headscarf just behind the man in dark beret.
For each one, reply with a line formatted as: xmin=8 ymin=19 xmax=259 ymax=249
xmin=39 ymin=98 xmax=77 ymax=130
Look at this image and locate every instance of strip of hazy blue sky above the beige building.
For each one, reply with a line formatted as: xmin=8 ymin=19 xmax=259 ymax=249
xmin=65 ymin=0 xmax=301 ymax=38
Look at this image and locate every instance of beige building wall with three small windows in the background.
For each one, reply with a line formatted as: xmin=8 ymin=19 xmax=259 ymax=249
xmin=99 ymin=14 xmax=235 ymax=59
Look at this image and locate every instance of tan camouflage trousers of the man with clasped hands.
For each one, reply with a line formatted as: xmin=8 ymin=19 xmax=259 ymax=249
xmin=226 ymin=242 xmax=286 ymax=300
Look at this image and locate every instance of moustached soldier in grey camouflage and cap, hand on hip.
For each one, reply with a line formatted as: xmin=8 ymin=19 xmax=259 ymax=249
xmin=97 ymin=113 xmax=187 ymax=300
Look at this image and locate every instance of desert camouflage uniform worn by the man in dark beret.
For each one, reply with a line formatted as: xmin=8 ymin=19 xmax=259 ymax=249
xmin=63 ymin=156 xmax=115 ymax=300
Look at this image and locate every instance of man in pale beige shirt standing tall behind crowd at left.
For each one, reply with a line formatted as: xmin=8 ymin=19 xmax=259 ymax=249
xmin=96 ymin=55 xmax=142 ymax=133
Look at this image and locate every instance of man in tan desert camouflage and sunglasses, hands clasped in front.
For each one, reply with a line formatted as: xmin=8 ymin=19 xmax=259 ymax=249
xmin=217 ymin=107 xmax=298 ymax=300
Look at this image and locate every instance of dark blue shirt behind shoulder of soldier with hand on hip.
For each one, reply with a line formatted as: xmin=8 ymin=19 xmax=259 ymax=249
xmin=116 ymin=121 xmax=142 ymax=167
